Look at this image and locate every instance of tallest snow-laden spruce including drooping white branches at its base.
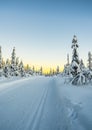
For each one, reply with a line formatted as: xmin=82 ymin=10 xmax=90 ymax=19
xmin=71 ymin=35 xmax=86 ymax=85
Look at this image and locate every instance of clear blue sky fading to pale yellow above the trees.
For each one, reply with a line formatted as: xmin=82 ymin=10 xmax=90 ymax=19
xmin=0 ymin=0 xmax=92 ymax=69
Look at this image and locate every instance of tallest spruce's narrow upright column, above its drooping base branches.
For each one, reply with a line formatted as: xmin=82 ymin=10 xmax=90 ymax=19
xmin=71 ymin=35 xmax=80 ymax=77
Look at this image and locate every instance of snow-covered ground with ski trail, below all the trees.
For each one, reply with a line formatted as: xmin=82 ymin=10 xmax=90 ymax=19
xmin=0 ymin=76 xmax=92 ymax=130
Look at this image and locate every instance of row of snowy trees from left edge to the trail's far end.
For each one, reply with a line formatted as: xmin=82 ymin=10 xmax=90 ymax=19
xmin=0 ymin=46 xmax=60 ymax=77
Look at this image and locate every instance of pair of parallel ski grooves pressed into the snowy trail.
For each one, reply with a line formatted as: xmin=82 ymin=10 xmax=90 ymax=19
xmin=25 ymin=86 xmax=49 ymax=130
